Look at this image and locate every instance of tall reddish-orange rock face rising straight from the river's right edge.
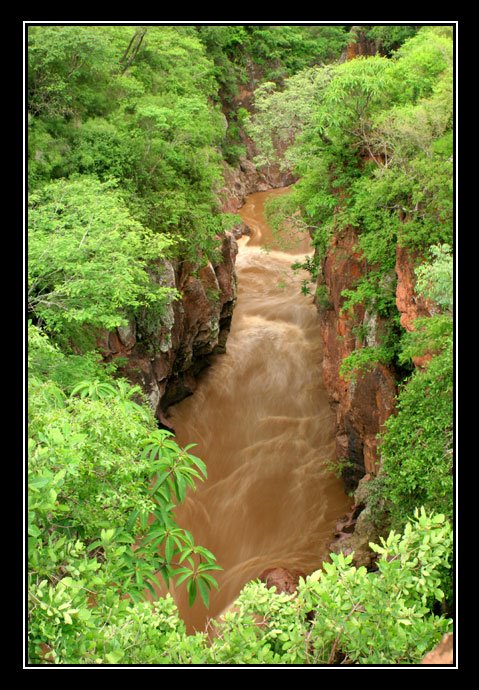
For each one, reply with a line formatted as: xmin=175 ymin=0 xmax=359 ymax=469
xmin=318 ymin=227 xmax=396 ymax=482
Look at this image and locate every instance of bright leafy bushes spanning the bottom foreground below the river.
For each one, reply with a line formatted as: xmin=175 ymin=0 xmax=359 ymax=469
xmin=27 ymin=511 xmax=452 ymax=665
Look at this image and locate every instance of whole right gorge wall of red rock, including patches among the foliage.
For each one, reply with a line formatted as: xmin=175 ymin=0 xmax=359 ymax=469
xmin=315 ymin=227 xmax=431 ymax=566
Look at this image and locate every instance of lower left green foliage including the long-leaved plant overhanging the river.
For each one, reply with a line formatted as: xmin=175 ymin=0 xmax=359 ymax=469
xmin=28 ymin=325 xmax=223 ymax=662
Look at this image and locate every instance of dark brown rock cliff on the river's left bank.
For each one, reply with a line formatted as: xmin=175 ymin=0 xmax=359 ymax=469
xmin=100 ymin=233 xmax=238 ymax=426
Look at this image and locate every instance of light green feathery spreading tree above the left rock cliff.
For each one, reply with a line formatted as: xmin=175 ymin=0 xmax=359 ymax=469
xmin=28 ymin=177 xmax=176 ymax=332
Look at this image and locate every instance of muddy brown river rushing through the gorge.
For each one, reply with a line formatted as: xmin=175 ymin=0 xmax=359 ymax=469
xmin=170 ymin=189 xmax=350 ymax=630
